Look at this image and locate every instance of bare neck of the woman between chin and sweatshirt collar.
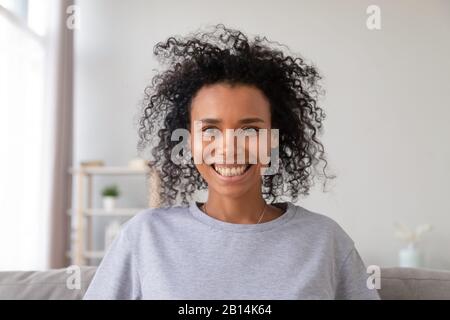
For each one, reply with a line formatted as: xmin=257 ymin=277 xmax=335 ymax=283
xmin=206 ymin=191 xmax=266 ymax=224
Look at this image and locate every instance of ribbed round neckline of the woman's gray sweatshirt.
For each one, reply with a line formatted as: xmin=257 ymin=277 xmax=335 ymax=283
xmin=189 ymin=201 xmax=296 ymax=232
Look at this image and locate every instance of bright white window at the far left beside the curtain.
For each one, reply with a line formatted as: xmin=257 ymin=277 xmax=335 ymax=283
xmin=0 ymin=0 xmax=49 ymax=269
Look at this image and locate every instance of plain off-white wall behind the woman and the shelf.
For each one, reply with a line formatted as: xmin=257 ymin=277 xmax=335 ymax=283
xmin=74 ymin=0 xmax=450 ymax=269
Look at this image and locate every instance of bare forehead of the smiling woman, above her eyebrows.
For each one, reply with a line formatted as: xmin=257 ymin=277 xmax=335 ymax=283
xmin=191 ymin=84 xmax=270 ymax=121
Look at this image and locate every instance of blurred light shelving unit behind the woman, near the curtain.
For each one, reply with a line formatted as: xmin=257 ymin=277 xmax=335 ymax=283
xmin=67 ymin=166 xmax=159 ymax=266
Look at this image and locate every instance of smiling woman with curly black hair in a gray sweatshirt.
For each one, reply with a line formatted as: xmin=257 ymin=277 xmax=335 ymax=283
xmin=84 ymin=25 xmax=379 ymax=299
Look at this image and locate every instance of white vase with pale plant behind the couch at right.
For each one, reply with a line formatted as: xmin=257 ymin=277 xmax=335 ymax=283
xmin=395 ymin=223 xmax=432 ymax=268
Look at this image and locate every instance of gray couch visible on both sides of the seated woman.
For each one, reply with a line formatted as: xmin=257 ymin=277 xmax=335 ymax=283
xmin=0 ymin=267 xmax=450 ymax=300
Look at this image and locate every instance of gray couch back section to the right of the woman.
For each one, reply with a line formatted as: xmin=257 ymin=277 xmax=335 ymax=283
xmin=379 ymin=267 xmax=450 ymax=300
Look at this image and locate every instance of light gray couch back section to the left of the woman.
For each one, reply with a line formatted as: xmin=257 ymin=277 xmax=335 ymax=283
xmin=0 ymin=267 xmax=96 ymax=300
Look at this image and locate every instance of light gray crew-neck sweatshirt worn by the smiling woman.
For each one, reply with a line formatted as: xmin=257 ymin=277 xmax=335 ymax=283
xmin=83 ymin=201 xmax=379 ymax=300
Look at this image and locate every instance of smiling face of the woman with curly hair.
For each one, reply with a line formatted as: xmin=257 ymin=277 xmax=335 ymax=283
xmin=190 ymin=83 xmax=271 ymax=197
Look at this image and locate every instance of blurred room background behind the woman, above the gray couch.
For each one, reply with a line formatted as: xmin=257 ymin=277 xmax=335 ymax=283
xmin=0 ymin=0 xmax=450 ymax=270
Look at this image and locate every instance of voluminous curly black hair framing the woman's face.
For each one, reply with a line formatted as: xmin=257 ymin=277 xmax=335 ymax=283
xmin=138 ymin=24 xmax=334 ymax=205
